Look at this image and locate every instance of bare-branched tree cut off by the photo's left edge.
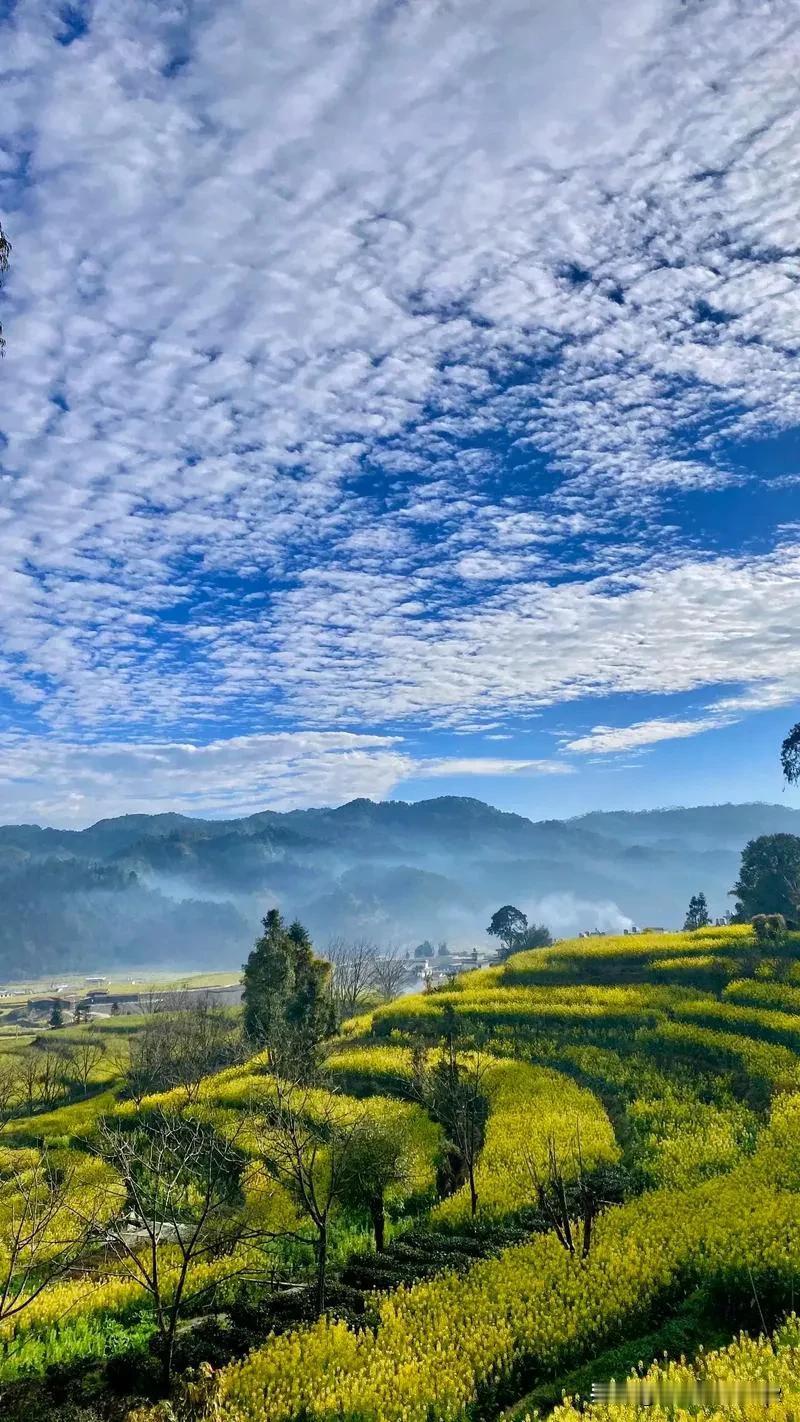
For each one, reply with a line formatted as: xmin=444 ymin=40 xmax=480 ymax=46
xmin=0 ymin=1152 xmax=95 ymax=1320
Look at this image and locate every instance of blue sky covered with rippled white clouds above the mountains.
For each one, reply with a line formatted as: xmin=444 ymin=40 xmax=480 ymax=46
xmin=0 ymin=0 xmax=800 ymax=826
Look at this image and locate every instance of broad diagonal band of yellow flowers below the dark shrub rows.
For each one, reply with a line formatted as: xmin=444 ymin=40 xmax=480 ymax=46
xmin=223 ymin=1098 xmax=800 ymax=1422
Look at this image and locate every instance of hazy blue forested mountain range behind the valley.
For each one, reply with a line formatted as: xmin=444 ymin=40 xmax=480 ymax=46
xmin=0 ymin=796 xmax=800 ymax=978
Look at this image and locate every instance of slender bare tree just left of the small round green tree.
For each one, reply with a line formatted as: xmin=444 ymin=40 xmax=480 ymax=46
xmin=254 ymin=1078 xmax=364 ymax=1314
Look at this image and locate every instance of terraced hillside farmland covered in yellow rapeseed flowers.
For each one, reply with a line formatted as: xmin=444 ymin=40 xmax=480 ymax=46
xmin=0 ymin=927 xmax=800 ymax=1422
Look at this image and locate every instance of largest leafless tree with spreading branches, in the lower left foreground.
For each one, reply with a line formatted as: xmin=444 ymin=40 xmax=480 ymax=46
xmin=95 ymin=1111 xmax=250 ymax=1389
